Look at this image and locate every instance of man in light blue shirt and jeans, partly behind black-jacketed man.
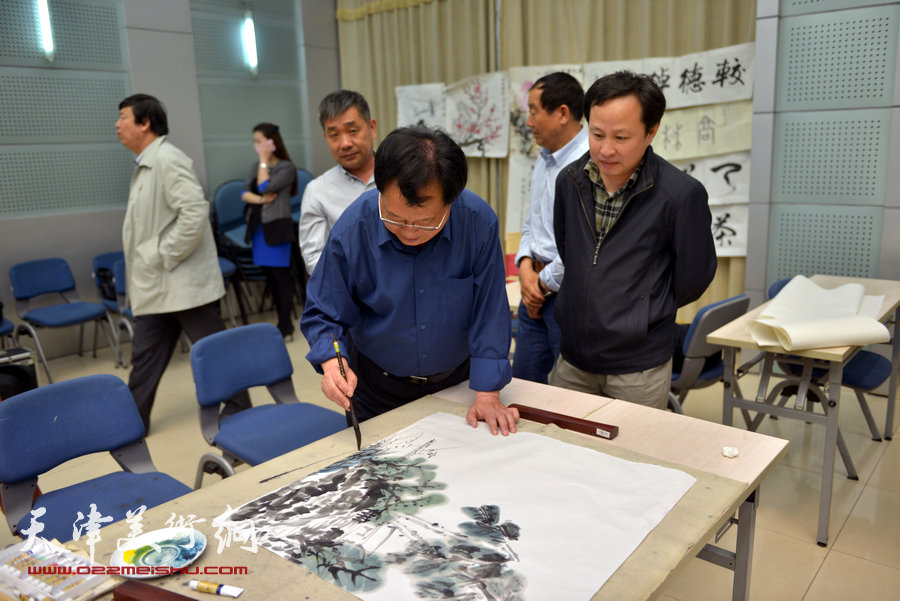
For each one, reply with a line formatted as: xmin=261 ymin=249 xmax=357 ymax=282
xmin=512 ymin=72 xmax=588 ymax=384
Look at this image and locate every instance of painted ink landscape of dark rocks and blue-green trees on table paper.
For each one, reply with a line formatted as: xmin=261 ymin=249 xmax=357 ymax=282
xmin=221 ymin=440 xmax=526 ymax=601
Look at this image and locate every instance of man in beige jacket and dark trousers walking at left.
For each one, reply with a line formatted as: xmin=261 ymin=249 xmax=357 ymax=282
xmin=116 ymin=94 xmax=250 ymax=430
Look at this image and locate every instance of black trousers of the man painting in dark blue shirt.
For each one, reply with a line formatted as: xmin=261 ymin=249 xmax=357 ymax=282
xmin=350 ymin=348 xmax=469 ymax=421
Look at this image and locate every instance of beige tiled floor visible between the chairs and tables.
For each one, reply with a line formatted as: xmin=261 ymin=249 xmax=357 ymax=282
xmin=0 ymin=312 xmax=900 ymax=601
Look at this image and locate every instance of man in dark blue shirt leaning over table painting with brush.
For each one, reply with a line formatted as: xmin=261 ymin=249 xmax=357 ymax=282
xmin=300 ymin=127 xmax=518 ymax=434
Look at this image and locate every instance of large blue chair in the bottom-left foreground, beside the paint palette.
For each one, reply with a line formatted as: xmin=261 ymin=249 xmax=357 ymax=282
xmin=0 ymin=375 xmax=191 ymax=541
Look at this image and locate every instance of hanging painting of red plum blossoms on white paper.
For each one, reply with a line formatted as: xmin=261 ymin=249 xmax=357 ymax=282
xmin=447 ymin=71 xmax=509 ymax=158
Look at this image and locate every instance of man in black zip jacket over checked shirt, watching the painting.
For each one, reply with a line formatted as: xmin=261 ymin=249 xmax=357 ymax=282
xmin=550 ymin=71 xmax=716 ymax=409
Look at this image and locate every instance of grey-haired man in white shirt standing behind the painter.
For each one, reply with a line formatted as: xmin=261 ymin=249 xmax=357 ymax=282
xmin=299 ymin=90 xmax=375 ymax=274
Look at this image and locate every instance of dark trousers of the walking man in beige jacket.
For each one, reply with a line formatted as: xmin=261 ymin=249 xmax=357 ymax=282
xmin=128 ymin=303 xmax=250 ymax=430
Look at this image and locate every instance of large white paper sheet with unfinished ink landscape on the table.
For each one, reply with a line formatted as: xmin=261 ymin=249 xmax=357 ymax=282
xmin=216 ymin=413 xmax=695 ymax=601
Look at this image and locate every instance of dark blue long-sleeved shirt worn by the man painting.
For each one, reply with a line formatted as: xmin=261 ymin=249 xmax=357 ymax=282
xmin=300 ymin=190 xmax=511 ymax=391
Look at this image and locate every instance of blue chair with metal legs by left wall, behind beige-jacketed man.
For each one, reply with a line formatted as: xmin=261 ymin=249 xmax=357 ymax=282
xmin=9 ymin=257 xmax=119 ymax=383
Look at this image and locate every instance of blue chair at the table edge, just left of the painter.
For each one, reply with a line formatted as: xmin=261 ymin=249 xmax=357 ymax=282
xmin=191 ymin=323 xmax=347 ymax=488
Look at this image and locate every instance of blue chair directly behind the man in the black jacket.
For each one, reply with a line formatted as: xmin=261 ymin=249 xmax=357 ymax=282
xmin=669 ymin=294 xmax=750 ymax=413
